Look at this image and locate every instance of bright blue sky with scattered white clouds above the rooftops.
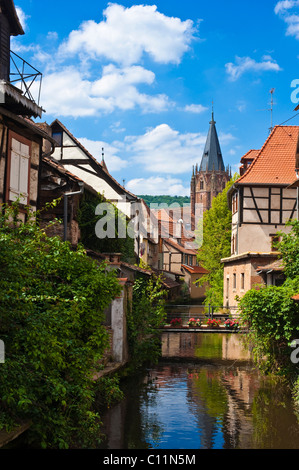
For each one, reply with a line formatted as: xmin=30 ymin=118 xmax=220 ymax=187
xmin=11 ymin=0 xmax=299 ymax=196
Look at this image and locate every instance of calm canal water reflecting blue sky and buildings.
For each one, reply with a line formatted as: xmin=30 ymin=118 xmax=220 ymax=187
xmin=103 ymin=332 xmax=299 ymax=449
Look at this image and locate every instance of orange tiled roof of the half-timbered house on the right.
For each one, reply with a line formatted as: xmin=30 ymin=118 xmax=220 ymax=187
xmin=236 ymin=126 xmax=299 ymax=185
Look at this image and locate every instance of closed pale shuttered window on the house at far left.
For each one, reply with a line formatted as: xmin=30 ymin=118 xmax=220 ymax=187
xmin=7 ymin=132 xmax=31 ymax=204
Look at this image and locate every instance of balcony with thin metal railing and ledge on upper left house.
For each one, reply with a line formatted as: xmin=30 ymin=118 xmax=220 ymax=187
xmin=0 ymin=51 xmax=43 ymax=117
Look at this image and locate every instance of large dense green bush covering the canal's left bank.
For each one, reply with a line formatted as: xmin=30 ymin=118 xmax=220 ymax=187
xmin=0 ymin=205 xmax=120 ymax=448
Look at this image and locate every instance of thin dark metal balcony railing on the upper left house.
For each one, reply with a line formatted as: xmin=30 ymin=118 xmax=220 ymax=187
xmin=10 ymin=51 xmax=43 ymax=106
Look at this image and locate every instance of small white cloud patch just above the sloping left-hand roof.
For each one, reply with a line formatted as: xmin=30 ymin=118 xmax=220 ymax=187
xmin=78 ymin=137 xmax=128 ymax=172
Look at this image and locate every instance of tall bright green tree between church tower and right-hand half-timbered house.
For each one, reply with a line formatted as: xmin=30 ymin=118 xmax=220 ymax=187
xmin=196 ymin=176 xmax=237 ymax=306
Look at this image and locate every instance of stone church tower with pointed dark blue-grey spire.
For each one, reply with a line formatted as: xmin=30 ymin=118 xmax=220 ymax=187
xmin=190 ymin=111 xmax=231 ymax=220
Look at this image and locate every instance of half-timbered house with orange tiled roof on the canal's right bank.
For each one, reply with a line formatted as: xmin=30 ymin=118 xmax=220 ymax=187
xmin=222 ymin=126 xmax=299 ymax=306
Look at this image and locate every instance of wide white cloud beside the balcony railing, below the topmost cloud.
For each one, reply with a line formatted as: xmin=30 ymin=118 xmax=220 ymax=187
xmin=38 ymin=65 xmax=172 ymax=117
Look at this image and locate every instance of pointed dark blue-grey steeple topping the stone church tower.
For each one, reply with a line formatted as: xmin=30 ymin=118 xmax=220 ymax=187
xmin=200 ymin=106 xmax=225 ymax=171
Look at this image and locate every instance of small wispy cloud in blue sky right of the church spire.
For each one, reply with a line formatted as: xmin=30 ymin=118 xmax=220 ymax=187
xmin=225 ymin=56 xmax=282 ymax=81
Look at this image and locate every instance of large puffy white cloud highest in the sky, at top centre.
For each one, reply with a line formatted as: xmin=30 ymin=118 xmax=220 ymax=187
xmin=59 ymin=3 xmax=195 ymax=65
